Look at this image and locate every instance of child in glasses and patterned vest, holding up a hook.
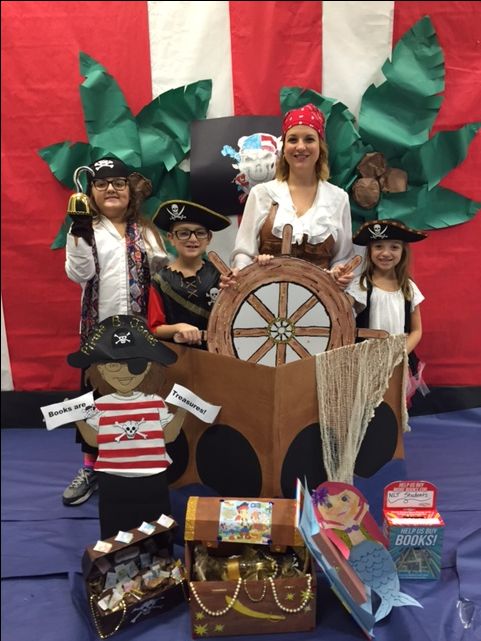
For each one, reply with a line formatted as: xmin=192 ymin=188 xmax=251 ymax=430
xmin=63 ymin=157 xmax=168 ymax=506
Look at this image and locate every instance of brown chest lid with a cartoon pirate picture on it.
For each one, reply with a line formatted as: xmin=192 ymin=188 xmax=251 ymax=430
xmin=185 ymin=496 xmax=304 ymax=548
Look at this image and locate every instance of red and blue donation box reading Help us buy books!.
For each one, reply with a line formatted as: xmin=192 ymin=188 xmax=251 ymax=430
xmin=384 ymin=481 xmax=444 ymax=579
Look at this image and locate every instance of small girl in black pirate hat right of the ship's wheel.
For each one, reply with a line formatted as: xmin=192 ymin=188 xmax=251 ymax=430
xmin=347 ymin=220 xmax=427 ymax=405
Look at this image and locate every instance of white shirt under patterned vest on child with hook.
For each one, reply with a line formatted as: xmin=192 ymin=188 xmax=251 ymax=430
xmin=65 ymin=216 xmax=168 ymax=330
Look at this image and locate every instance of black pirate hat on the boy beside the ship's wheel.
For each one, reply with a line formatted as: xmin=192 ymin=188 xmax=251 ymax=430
xmin=152 ymin=200 xmax=230 ymax=231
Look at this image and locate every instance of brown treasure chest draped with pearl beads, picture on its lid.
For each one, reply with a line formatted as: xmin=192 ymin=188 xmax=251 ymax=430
xmin=185 ymin=497 xmax=316 ymax=638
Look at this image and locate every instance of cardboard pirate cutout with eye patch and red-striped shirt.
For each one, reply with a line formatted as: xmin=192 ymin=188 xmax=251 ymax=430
xmin=67 ymin=316 xmax=185 ymax=538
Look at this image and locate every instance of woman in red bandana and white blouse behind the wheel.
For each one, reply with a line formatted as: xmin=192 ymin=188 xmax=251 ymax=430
xmin=227 ymin=104 xmax=354 ymax=288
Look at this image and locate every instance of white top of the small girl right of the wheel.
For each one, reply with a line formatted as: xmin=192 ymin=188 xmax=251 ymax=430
xmin=346 ymin=277 xmax=424 ymax=334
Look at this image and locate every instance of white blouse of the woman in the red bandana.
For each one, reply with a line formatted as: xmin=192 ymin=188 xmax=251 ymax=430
xmin=231 ymin=180 xmax=354 ymax=269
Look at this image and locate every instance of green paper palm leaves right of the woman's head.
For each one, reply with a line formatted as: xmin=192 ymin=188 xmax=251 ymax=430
xmin=280 ymin=16 xmax=481 ymax=231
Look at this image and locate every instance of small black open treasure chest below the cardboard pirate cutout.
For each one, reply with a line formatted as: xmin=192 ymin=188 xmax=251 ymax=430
xmin=82 ymin=516 xmax=186 ymax=639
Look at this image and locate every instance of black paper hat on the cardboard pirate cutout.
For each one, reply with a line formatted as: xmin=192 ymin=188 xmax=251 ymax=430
xmin=67 ymin=315 xmax=177 ymax=373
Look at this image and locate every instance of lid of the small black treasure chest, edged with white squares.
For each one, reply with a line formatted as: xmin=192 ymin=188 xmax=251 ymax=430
xmin=82 ymin=514 xmax=177 ymax=577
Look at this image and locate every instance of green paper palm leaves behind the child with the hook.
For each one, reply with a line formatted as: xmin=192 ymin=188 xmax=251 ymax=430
xmin=38 ymin=53 xmax=212 ymax=249
